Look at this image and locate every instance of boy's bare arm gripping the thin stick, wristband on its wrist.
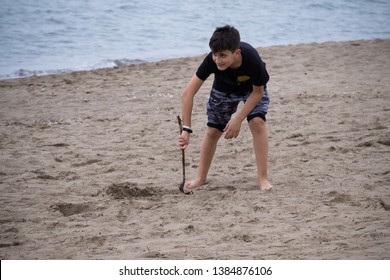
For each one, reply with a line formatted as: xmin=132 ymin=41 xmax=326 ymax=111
xmin=179 ymin=75 xmax=204 ymax=150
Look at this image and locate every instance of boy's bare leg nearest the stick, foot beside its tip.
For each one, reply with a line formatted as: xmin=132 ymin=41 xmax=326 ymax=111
xmin=185 ymin=127 xmax=223 ymax=189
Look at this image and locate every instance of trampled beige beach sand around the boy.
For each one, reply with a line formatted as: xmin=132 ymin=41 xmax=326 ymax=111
xmin=0 ymin=40 xmax=390 ymax=260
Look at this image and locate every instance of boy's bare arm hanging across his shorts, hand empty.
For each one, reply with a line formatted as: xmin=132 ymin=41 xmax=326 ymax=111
xmin=224 ymin=85 xmax=264 ymax=139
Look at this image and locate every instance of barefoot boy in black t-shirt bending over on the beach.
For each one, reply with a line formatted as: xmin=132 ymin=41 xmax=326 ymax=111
xmin=179 ymin=25 xmax=272 ymax=193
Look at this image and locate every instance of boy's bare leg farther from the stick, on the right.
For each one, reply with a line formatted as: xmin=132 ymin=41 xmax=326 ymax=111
xmin=249 ymin=117 xmax=272 ymax=190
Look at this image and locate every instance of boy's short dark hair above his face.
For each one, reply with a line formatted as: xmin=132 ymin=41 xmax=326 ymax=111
xmin=209 ymin=25 xmax=241 ymax=53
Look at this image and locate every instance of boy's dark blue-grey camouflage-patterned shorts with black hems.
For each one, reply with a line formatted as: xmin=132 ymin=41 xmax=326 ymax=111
xmin=207 ymin=88 xmax=269 ymax=131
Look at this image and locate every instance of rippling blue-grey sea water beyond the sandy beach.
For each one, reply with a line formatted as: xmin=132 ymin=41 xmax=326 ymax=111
xmin=0 ymin=0 xmax=390 ymax=79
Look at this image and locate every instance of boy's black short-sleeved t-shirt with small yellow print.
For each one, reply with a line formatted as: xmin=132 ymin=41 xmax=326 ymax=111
xmin=196 ymin=42 xmax=269 ymax=94
